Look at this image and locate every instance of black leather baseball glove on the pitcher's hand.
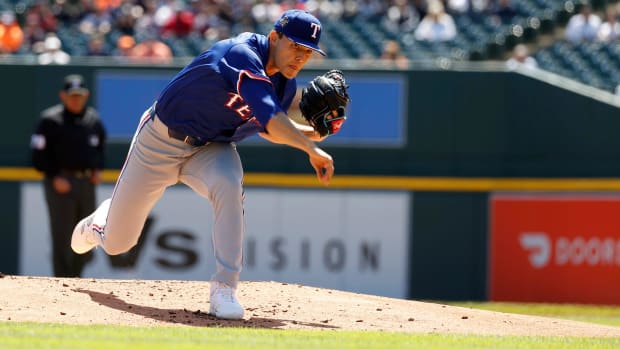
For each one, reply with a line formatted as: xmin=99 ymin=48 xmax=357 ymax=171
xmin=299 ymin=70 xmax=351 ymax=137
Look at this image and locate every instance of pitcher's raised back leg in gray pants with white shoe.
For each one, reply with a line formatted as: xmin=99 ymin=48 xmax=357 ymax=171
xmin=72 ymin=113 xmax=186 ymax=255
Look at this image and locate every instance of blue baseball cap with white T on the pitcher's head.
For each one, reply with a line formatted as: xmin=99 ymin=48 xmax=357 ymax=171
xmin=273 ymin=10 xmax=325 ymax=56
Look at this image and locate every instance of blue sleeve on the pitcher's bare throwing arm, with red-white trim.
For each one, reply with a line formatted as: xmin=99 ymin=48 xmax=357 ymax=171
xmin=220 ymin=45 xmax=284 ymax=127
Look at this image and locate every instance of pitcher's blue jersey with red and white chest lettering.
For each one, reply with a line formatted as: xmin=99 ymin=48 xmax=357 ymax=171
xmin=155 ymin=33 xmax=297 ymax=142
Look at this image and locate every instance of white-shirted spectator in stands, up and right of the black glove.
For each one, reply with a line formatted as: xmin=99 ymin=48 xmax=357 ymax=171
xmin=415 ymin=0 xmax=456 ymax=42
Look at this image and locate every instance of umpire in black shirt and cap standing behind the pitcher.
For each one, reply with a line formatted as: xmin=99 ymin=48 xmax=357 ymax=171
xmin=30 ymin=74 xmax=106 ymax=277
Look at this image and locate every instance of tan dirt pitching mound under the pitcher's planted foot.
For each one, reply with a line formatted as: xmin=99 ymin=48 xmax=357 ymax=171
xmin=0 ymin=275 xmax=620 ymax=337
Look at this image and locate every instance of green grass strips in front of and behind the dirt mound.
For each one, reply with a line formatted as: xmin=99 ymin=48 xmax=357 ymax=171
xmin=0 ymin=303 xmax=620 ymax=349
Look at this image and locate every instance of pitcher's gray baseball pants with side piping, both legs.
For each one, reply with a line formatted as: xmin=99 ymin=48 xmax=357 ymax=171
xmin=99 ymin=110 xmax=245 ymax=287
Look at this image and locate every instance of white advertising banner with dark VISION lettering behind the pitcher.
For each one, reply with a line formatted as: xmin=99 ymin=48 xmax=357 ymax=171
xmin=20 ymin=183 xmax=411 ymax=298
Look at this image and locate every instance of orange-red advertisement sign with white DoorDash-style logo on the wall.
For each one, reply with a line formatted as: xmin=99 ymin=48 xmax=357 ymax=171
xmin=489 ymin=194 xmax=620 ymax=304
